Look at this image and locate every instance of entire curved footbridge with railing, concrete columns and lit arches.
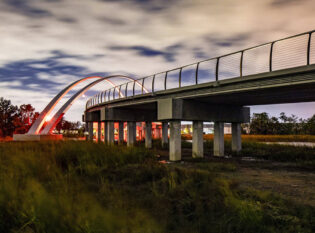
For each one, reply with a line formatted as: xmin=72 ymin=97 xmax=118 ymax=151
xmin=15 ymin=31 xmax=315 ymax=161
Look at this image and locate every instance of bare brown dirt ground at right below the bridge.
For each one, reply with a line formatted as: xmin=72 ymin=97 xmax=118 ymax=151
xmin=157 ymin=149 xmax=315 ymax=207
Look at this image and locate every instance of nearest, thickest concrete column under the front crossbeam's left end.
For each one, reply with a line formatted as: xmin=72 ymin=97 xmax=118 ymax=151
xmin=169 ymin=121 xmax=182 ymax=161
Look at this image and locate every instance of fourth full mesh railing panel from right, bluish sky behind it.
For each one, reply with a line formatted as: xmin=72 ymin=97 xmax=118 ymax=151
xmin=198 ymin=59 xmax=217 ymax=84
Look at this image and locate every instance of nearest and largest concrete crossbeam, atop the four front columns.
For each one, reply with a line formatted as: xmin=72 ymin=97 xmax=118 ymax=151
xmin=157 ymin=99 xmax=250 ymax=122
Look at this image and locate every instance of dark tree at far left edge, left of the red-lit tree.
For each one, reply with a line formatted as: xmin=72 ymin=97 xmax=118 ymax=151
xmin=0 ymin=97 xmax=18 ymax=137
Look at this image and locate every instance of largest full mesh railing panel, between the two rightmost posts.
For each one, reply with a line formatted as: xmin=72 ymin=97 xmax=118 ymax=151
xmin=272 ymin=35 xmax=308 ymax=70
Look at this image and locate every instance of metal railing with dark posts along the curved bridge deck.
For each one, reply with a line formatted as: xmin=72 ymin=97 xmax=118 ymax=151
xmin=86 ymin=30 xmax=315 ymax=107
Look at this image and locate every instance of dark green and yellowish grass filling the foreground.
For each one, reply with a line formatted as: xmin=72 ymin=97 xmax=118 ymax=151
xmin=0 ymin=141 xmax=315 ymax=233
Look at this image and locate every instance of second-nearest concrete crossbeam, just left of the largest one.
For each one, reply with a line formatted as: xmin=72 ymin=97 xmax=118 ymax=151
xmin=100 ymin=107 xmax=157 ymax=122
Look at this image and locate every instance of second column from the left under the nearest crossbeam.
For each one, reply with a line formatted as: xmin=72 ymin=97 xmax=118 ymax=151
xmin=192 ymin=121 xmax=203 ymax=158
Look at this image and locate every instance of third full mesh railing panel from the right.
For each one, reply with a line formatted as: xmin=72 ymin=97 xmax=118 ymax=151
xmin=219 ymin=53 xmax=241 ymax=80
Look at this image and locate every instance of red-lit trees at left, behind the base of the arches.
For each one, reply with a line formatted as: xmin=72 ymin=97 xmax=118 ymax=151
xmin=0 ymin=97 xmax=84 ymax=138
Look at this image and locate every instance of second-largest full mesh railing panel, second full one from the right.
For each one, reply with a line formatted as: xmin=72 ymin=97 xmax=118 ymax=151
xmin=242 ymin=44 xmax=271 ymax=76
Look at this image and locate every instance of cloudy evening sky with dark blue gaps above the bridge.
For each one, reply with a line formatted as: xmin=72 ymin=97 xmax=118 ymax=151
xmin=0 ymin=0 xmax=315 ymax=121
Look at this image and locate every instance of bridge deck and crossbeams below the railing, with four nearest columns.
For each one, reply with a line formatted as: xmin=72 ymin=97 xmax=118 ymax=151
xmin=85 ymin=65 xmax=315 ymax=160
